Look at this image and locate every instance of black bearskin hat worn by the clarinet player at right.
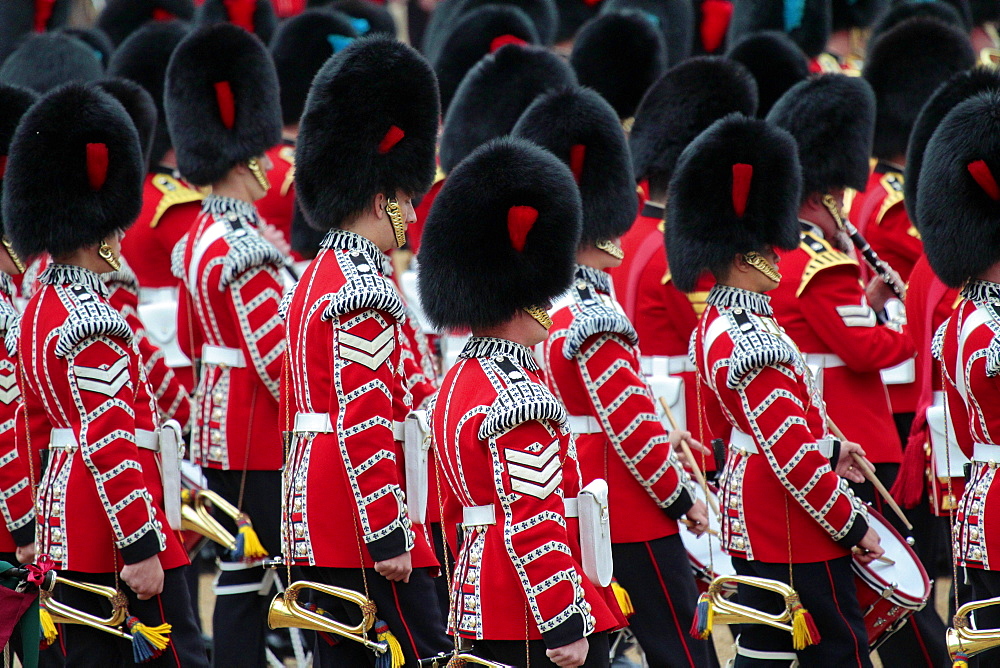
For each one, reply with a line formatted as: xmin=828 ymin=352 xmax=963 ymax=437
xmin=767 ymin=74 xmax=875 ymax=199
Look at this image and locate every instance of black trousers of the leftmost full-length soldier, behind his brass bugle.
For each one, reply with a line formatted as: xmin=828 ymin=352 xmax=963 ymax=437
xmin=57 ymin=566 xmax=208 ymax=668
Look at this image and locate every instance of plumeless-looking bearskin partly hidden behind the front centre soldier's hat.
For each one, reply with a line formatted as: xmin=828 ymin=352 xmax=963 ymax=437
xmin=440 ymin=44 xmax=576 ymax=174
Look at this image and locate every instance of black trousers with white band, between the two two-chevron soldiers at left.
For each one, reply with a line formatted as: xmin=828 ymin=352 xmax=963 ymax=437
xmin=203 ymin=468 xmax=281 ymax=668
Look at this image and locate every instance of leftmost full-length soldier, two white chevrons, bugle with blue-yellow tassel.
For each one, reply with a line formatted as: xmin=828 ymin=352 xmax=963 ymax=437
xmin=3 ymin=84 xmax=207 ymax=666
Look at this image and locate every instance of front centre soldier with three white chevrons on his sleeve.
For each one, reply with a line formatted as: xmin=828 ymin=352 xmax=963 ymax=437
xmin=420 ymin=138 xmax=619 ymax=666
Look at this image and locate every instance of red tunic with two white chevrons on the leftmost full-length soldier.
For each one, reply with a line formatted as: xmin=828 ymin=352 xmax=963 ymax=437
xmin=17 ymin=264 xmax=188 ymax=573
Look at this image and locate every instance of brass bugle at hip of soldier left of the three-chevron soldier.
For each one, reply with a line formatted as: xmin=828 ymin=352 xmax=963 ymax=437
xmin=267 ymin=580 xmax=389 ymax=654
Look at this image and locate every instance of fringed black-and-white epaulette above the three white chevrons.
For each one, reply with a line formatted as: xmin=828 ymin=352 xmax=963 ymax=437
xmin=479 ymin=357 xmax=567 ymax=440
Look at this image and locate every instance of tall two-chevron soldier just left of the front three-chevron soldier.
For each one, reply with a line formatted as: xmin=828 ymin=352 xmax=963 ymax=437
xmin=281 ymin=37 xmax=451 ymax=666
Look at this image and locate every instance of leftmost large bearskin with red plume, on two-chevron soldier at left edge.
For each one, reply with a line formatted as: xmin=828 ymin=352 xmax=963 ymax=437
xmin=3 ymin=83 xmax=145 ymax=258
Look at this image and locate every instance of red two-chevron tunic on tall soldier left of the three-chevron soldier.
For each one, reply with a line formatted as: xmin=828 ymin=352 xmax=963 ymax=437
xmin=281 ymin=230 xmax=437 ymax=568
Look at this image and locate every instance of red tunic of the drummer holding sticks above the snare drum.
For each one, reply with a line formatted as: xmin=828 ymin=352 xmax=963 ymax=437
xmin=691 ymin=285 xmax=868 ymax=563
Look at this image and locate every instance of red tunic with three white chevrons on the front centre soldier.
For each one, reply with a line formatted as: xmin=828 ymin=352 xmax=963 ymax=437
xmin=433 ymin=337 xmax=618 ymax=647
